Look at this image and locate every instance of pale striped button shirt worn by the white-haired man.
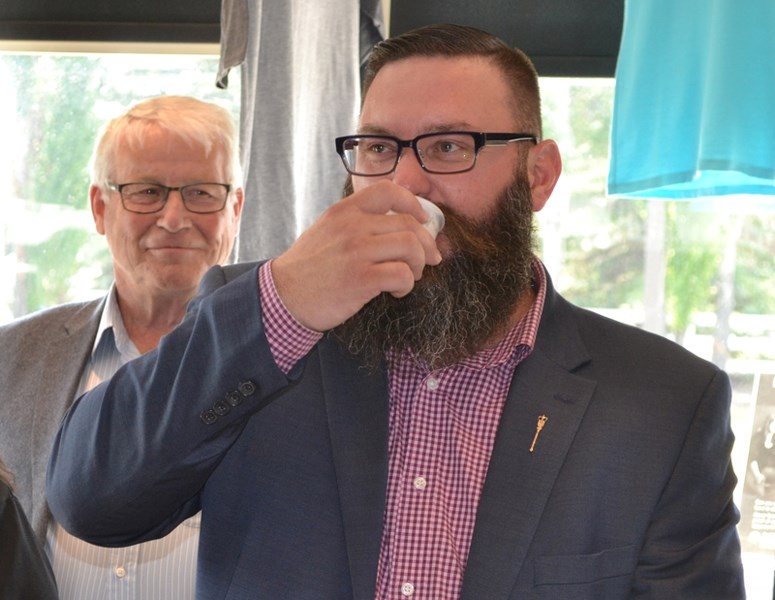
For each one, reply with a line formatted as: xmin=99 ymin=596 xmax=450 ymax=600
xmin=46 ymin=286 xmax=201 ymax=600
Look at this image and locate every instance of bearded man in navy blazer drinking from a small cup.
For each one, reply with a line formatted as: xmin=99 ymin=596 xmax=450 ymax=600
xmin=48 ymin=25 xmax=744 ymax=600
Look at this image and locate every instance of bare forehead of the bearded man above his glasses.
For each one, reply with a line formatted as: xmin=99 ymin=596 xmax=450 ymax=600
xmin=360 ymin=57 xmax=515 ymax=136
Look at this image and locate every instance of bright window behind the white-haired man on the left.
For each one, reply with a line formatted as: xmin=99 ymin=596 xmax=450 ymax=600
xmin=0 ymin=44 xmax=239 ymax=323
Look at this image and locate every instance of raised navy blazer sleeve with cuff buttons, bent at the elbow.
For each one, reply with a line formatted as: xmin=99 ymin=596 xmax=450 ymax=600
xmin=46 ymin=266 xmax=298 ymax=546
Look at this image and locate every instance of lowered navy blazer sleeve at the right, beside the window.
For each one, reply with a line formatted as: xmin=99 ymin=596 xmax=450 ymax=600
xmin=632 ymin=370 xmax=745 ymax=600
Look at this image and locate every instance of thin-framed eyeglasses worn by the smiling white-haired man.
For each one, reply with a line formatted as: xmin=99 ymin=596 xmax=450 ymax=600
xmin=108 ymin=182 xmax=231 ymax=215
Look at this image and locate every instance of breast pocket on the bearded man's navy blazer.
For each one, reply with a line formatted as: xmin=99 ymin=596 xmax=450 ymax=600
xmin=534 ymin=546 xmax=636 ymax=585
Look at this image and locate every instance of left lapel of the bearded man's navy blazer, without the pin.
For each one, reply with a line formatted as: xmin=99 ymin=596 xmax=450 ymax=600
xmin=319 ymin=341 xmax=388 ymax=600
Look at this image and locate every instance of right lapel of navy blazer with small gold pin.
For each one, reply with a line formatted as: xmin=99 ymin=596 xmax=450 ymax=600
xmin=461 ymin=282 xmax=596 ymax=600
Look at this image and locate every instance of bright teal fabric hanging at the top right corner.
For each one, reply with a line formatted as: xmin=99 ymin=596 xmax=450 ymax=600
xmin=608 ymin=0 xmax=775 ymax=198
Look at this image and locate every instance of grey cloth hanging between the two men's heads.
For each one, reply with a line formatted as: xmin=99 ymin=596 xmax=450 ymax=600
xmin=218 ymin=0 xmax=383 ymax=261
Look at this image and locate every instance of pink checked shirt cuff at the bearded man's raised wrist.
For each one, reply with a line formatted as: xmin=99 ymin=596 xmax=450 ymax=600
xmin=258 ymin=261 xmax=323 ymax=375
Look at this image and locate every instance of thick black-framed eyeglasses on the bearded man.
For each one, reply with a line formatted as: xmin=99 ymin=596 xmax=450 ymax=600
xmin=336 ymin=131 xmax=538 ymax=177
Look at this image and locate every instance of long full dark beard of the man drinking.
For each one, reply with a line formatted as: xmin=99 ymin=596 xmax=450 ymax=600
xmin=333 ymin=175 xmax=533 ymax=369
